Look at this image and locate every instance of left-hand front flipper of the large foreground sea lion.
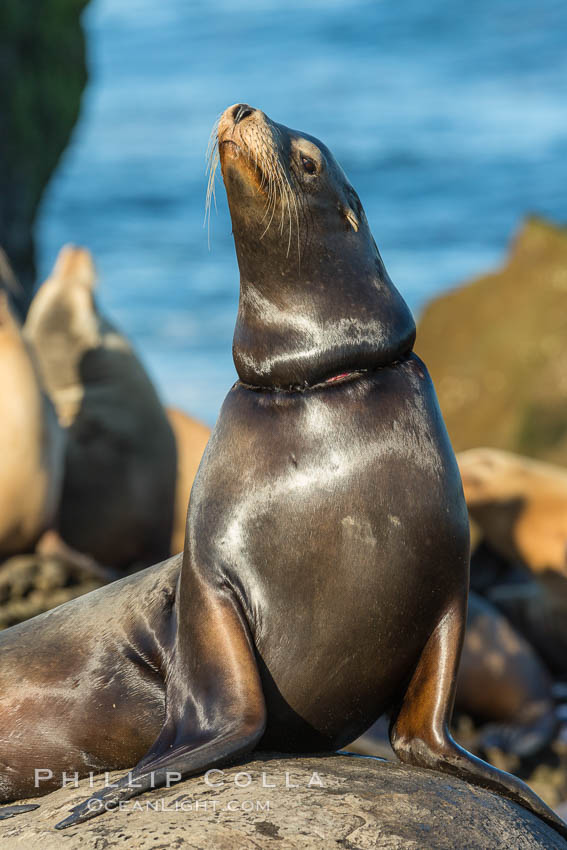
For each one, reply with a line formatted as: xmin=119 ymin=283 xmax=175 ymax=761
xmin=56 ymin=565 xmax=265 ymax=829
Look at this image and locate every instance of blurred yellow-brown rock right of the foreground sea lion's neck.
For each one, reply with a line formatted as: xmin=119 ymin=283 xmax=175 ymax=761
xmin=417 ymin=214 xmax=567 ymax=465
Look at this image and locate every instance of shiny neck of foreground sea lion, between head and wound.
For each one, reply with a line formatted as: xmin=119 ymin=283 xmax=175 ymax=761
xmin=233 ymin=237 xmax=415 ymax=388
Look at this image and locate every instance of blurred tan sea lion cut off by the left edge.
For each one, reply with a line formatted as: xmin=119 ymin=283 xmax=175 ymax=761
xmin=0 ymin=264 xmax=65 ymax=558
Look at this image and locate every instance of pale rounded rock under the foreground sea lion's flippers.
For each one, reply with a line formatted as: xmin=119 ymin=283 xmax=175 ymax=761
xmin=0 ymin=755 xmax=567 ymax=850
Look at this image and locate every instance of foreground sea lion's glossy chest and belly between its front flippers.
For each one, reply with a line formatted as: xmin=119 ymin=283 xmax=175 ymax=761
xmin=189 ymin=355 xmax=468 ymax=747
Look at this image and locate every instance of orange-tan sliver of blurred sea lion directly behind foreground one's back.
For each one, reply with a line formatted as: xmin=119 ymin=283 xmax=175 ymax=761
xmin=166 ymin=407 xmax=211 ymax=554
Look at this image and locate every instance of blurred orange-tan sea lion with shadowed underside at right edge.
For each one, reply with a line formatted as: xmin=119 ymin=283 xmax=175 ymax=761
xmin=458 ymin=448 xmax=567 ymax=677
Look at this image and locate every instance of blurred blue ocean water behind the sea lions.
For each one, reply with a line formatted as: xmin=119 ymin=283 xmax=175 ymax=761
xmin=38 ymin=0 xmax=567 ymax=424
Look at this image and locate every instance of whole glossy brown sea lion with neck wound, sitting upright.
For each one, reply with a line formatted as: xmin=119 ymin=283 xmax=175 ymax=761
xmin=0 ymin=104 xmax=567 ymax=834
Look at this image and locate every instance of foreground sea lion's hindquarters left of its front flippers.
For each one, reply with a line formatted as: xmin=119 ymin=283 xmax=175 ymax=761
xmin=0 ymin=556 xmax=181 ymax=796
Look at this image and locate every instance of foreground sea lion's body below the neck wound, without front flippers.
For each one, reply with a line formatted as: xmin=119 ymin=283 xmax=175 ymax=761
xmin=0 ymin=348 xmax=467 ymax=780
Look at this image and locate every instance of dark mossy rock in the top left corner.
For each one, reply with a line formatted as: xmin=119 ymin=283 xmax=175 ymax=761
xmin=0 ymin=0 xmax=88 ymax=306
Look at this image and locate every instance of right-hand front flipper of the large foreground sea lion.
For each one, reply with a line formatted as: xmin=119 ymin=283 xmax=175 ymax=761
xmin=390 ymin=599 xmax=567 ymax=838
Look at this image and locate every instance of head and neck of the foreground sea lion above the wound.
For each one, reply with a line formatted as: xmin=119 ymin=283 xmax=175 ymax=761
xmin=210 ymin=103 xmax=415 ymax=390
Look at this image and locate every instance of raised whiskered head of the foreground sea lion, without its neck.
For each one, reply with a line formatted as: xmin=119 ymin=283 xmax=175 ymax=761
xmin=218 ymin=104 xmax=372 ymax=253
